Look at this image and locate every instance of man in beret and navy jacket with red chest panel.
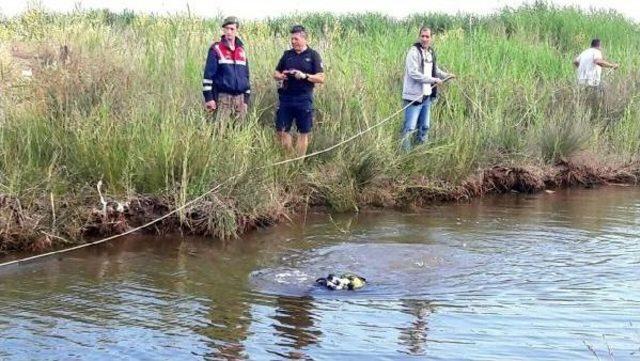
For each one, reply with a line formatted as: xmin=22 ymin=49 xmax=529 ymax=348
xmin=202 ymin=16 xmax=251 ymax=118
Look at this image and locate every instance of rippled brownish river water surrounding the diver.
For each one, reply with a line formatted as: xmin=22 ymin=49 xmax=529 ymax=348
xmin=0 ymin=188 xmax=640 ymax=360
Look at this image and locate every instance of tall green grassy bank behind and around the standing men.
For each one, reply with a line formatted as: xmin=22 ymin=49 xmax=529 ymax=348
xmin=0 ymin=4 xmax=640 ymax=251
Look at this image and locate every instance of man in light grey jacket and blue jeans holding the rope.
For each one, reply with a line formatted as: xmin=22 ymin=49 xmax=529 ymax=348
xmin=402 ymin=27 xmax=455 ymax=150
